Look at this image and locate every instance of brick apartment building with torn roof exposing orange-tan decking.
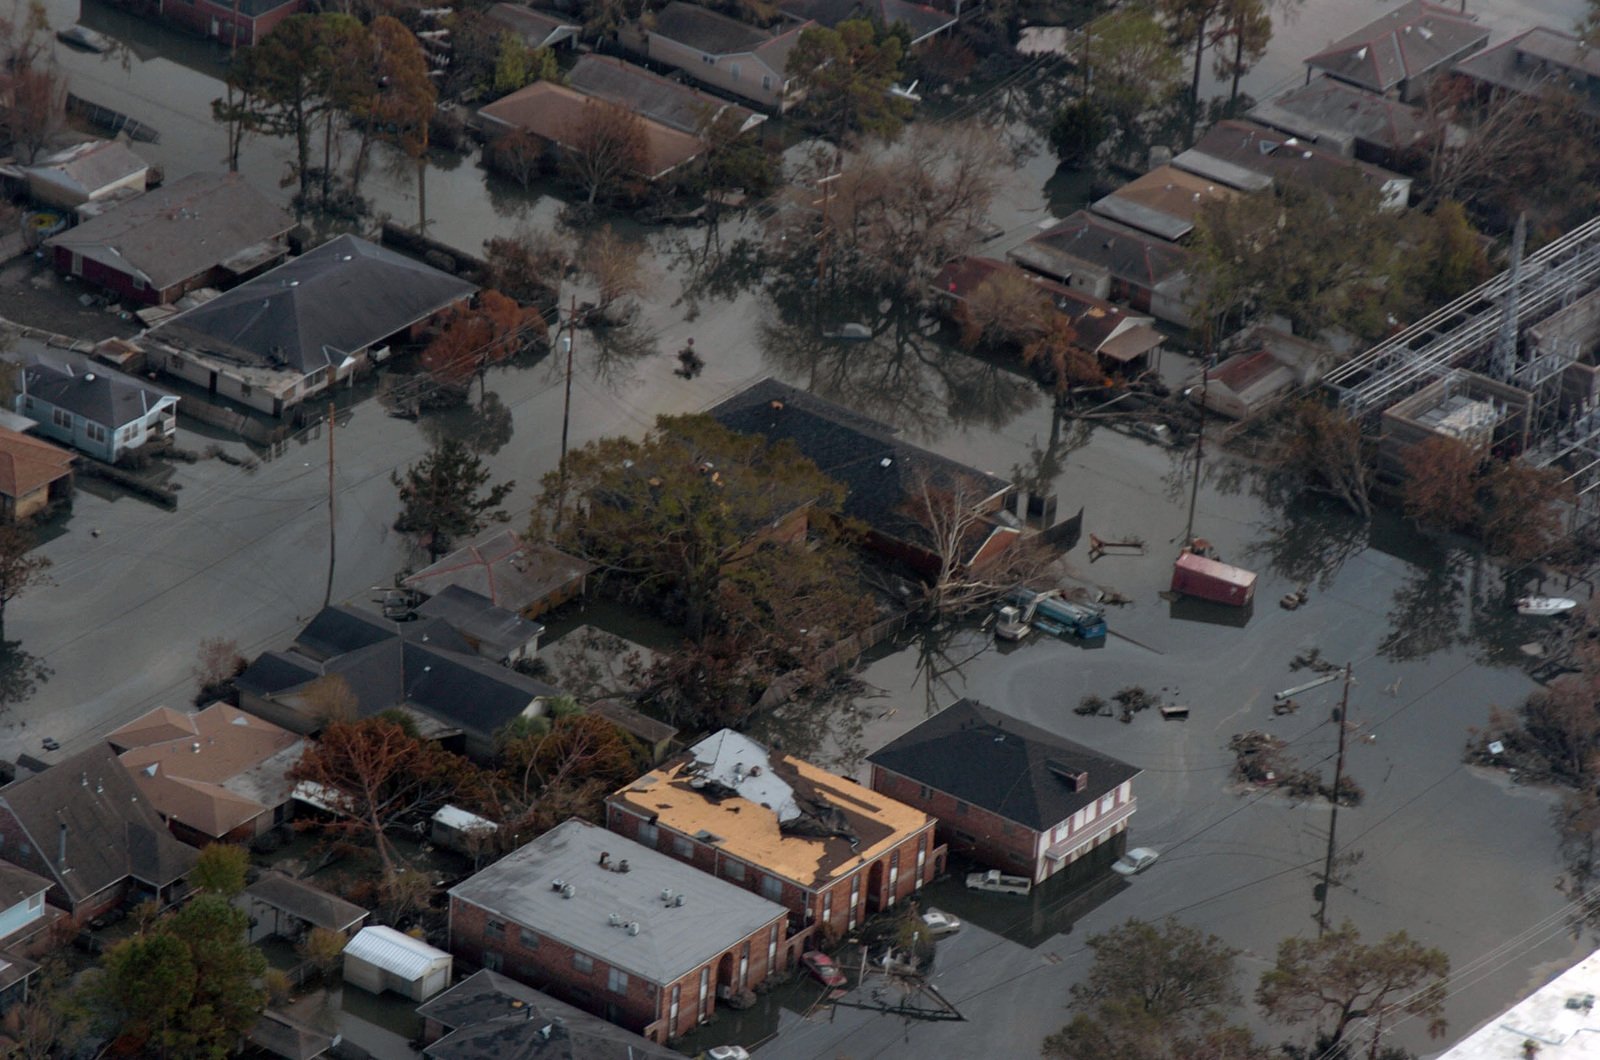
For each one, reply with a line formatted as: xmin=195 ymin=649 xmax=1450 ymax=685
xmin=606 ymin=729 xmax=944 ymax=938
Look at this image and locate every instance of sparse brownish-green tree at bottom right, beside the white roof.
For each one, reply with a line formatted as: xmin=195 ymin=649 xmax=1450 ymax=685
xmin=1256 ymin=921 xmax=1450 ymax=1055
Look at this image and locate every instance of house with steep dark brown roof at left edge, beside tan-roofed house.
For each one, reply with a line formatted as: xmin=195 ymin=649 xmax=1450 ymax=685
xmin=0 ymin=746 xmax=198 ymax=924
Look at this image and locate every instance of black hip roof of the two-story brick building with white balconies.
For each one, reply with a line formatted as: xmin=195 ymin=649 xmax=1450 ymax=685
xmin=867 ymin=700 xmax=1139 ymax=831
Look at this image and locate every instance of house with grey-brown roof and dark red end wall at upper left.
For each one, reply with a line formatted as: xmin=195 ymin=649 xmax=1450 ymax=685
xmin=45 ymin=173 xmax=294 ymax=306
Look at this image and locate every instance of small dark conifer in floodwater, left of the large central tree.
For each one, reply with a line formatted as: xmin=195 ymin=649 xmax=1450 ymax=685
xmin=390 ymin=437 xmax=515 ymax=559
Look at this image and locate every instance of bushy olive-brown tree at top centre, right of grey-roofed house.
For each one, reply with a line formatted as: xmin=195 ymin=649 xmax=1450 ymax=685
xmin=787 ymin=19 xmax=910 ymax=143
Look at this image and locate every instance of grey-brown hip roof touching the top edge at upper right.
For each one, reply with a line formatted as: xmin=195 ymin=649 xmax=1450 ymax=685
xmin=1306 ymin=0 xmax=1490 ymax=93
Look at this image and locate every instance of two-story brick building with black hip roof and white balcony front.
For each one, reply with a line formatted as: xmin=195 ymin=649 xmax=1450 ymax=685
xmin=867 ymin=700 xmax=1139 ymax=884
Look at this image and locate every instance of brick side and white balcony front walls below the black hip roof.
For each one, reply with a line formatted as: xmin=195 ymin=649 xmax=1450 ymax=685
xmin=872 ymin=765 xmax=1133 ymax=882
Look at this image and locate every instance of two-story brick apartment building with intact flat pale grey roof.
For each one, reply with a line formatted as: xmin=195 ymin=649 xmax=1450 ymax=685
xmin=450 ymin=818 xmax=789 ymax=1042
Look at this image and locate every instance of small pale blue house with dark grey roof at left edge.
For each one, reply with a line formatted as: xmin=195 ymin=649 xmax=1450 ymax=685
xmin=16 ymin=355 xmax=178 ymax=463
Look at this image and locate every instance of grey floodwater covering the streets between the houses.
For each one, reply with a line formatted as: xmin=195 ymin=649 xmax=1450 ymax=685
xmin=9 ymin=0 xmax=1584 ymax=1058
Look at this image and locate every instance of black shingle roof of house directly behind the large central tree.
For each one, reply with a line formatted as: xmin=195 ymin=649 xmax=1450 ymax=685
xmin=709 ymin=378 xmax=1011 ymax=557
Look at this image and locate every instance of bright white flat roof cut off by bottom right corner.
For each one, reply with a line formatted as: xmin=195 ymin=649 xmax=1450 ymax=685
xmin=1437 ymin=950 xmax=1600 ymax=1060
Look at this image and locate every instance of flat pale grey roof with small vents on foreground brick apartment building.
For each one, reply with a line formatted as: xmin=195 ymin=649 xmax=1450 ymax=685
xmin=450 ymin=818 xmax=787 ymax=983
